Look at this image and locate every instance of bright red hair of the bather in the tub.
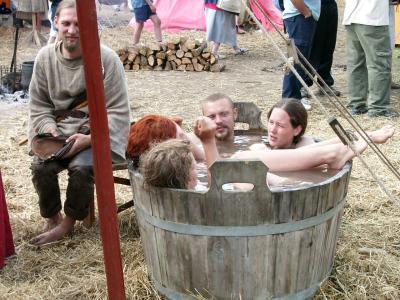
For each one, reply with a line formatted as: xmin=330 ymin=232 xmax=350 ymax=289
xmin=126 ymin=115 xmax=176 ymax=167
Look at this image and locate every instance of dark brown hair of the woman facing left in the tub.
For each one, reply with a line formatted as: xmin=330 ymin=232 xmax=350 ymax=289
xmin=267 ymin=98 xmax=308 ymax=144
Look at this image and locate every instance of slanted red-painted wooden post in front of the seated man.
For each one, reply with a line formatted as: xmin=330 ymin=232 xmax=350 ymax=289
xmin=76 ymin=0 xmax=125 ymax=300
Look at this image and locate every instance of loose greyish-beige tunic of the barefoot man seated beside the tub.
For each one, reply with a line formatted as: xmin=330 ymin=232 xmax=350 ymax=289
xmin=29 ymin=42 xmax=130 ymax=162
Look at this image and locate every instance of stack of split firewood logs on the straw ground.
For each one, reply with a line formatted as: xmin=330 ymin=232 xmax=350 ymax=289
xmin=117 ymin=37 xmax=225 ymax=72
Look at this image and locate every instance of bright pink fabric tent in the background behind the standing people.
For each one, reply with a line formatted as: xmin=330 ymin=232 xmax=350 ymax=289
xmin=129 ymin=0 xmax=283 ymax=32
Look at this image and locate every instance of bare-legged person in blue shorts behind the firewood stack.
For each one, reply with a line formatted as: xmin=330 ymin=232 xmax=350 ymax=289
xmin=132 ymin=0 xmax=162 ymax=45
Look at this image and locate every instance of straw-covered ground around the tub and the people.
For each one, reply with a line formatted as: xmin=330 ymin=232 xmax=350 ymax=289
xmin=0 ymin=2 xmax=400 ymax=300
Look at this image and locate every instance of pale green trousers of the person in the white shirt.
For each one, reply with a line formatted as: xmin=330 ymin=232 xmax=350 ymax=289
xmin=346 ymin=24 xmax=392 ymax=113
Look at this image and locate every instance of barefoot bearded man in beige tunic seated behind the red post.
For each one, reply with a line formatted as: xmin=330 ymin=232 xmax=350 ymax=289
xmin=29 ymin=0 xmax=130 ymax=245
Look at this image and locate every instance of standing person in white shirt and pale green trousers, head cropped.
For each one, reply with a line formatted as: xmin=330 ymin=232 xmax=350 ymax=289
xmin=343 ymin=0 xmax=398 ymax=118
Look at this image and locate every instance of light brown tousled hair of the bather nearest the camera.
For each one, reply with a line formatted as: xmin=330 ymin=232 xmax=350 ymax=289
xmin=139 ymin=139 xmax=194 ymax=189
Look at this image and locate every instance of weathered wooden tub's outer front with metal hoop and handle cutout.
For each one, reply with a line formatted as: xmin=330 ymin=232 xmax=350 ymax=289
xmin=130 ymin=160 xmax=351 ymax=299
